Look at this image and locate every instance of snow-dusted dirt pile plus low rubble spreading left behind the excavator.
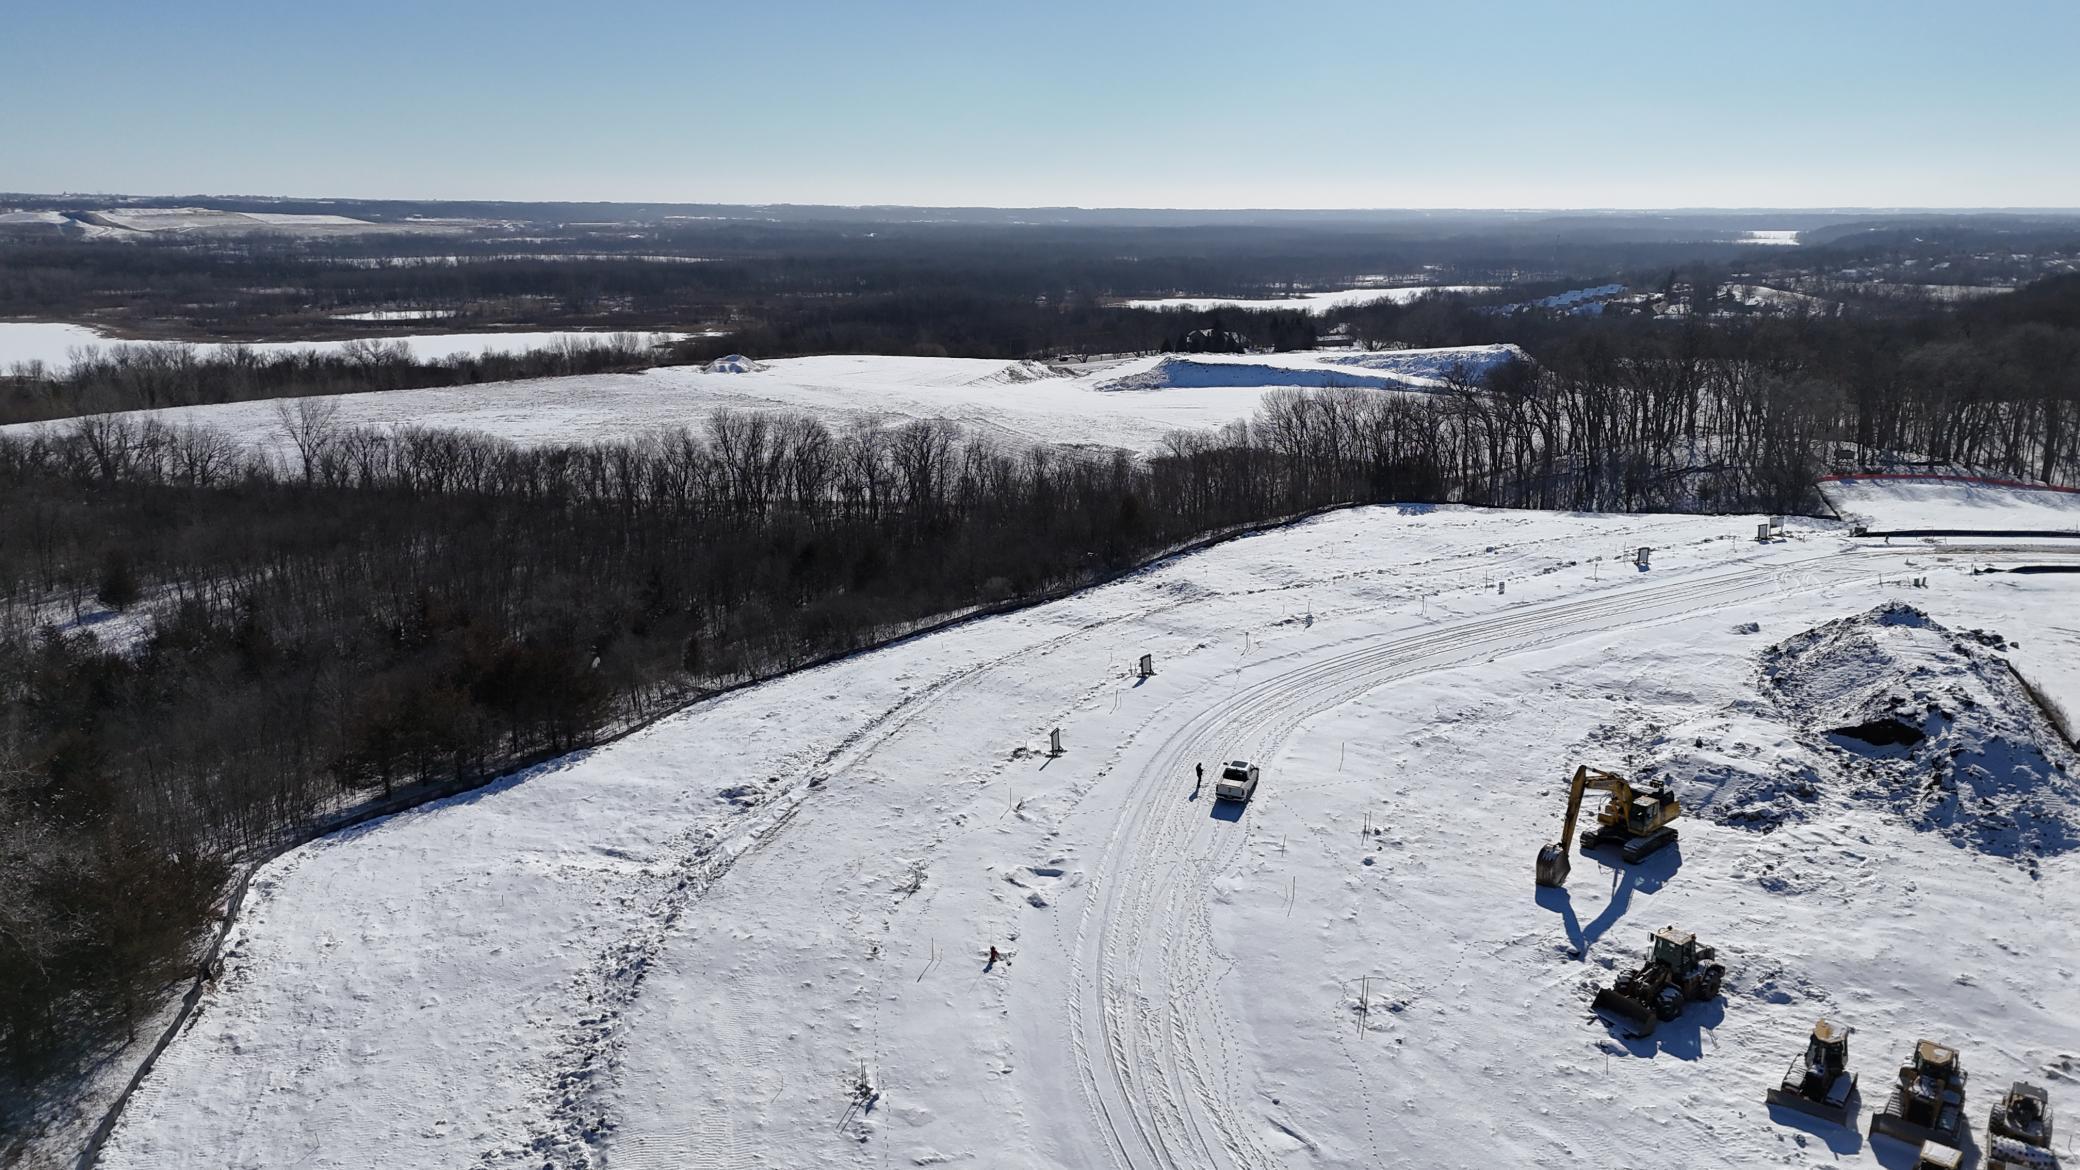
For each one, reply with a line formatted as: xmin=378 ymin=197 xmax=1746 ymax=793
xmin=1622 ymin=602 xmax=2080 ymax=853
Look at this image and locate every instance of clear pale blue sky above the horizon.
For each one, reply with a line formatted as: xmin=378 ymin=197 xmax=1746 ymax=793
xmin=0 ymin=0 xmax=2080 ymax=208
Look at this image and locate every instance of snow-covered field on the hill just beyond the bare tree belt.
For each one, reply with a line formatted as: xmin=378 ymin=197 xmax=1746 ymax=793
xmin=17 ymin=346 xmax=1516 ymax=450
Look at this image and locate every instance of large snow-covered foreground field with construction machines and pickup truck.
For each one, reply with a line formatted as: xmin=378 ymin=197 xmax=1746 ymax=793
xmin=104 ymin=506 xmax=2080 ymax=1170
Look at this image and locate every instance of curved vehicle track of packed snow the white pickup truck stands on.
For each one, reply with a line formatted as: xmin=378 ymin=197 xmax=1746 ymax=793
xmin=1067 ymin=556 xmax=1847 ymax=1170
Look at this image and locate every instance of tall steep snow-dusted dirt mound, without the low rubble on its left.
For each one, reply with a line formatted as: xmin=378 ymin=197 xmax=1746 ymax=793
xmin=1758 ymin=604 xmax=2080 ymax=858
